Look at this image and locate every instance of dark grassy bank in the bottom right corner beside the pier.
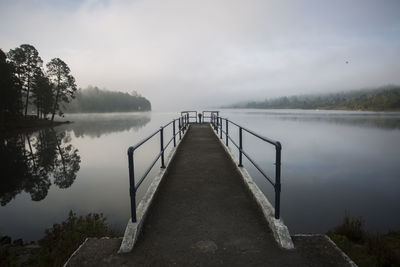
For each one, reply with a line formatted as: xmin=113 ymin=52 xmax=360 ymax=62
xmin=327 ymin=213 xmax=400 ymax=267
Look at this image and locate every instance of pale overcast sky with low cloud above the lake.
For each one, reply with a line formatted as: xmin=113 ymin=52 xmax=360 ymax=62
xmin=0 ymin=0 xmax=400 ymax=110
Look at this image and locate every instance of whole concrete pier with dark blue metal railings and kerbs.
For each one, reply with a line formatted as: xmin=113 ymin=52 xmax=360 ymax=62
xmin=66 ymin=112 xmax=354 ymax=266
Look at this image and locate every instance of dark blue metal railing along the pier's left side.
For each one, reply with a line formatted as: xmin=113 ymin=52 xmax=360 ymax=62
xmin=128 ymin=113 xmax=189 ymax=222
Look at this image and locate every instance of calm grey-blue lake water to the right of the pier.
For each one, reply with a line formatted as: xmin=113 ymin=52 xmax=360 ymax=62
xmin=222 ymin=110 xmax=400 ymax=233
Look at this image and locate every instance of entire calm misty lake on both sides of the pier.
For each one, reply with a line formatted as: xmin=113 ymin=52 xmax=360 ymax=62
xmin=0 ymin=110 xmax=400 ymax=241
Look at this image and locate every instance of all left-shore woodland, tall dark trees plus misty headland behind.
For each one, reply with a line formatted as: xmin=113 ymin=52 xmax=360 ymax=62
xmin=0 ymin=44 xmax=151 ymax=130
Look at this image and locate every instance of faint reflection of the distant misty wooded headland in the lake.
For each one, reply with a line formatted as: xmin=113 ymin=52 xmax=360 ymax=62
xmin=62 ymin=113 xmax=151 ymax=138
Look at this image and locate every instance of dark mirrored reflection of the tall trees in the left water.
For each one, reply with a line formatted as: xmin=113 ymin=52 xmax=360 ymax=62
xmin=0 ymin=128 xmax=81 ymax=206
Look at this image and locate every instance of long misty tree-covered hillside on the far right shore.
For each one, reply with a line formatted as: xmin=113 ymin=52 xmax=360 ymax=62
xmin=230 ymin=85 xmax=400 ymax=111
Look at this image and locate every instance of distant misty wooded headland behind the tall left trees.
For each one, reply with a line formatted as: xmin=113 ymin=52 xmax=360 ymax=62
xmin=63 ymin=86 xmax=151 ymax=113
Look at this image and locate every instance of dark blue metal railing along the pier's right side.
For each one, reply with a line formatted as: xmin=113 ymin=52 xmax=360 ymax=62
xmin=211 ymin=113 xmax=282 ymax=219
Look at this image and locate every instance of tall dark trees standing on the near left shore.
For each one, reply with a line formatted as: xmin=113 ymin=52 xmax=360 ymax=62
xmin=0 ymin=44 xmax=77 ymax=121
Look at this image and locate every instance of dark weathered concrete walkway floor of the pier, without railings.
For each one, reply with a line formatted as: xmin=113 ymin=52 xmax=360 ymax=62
xmin=68 ymin=125 xmax=356 ymax=266
